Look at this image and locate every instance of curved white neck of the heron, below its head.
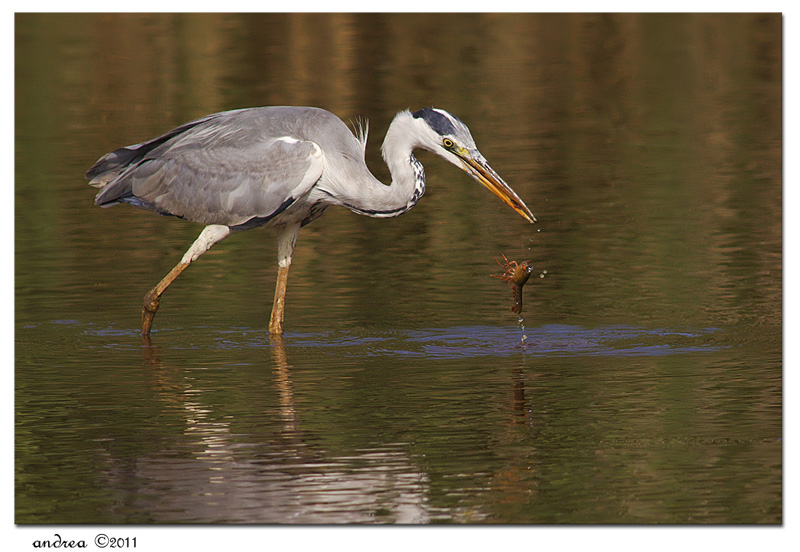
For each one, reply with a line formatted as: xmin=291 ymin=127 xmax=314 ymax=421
xmin=336 ymin=111 xmax=425 ymax=217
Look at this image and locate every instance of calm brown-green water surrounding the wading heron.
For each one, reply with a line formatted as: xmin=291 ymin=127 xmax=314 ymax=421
xmin=15 ymin=10 xmax=783 ymax=524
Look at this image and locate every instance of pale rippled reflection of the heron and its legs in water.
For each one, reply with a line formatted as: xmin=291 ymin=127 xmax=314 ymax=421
xmin=132 ymin=337 xmax=429 ymax=523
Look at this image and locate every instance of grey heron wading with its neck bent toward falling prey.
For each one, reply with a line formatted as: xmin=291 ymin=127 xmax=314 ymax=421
xmin=86 ymin=106 xmax=536 ymax=336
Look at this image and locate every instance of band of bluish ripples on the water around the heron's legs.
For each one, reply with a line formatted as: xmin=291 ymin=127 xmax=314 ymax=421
xmin=72 ymin=324 xmax=731 ymax=359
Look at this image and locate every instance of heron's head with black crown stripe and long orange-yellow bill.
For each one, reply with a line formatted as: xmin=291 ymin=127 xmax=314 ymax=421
xmin=411 ymin=107 xmax=536 ymax=223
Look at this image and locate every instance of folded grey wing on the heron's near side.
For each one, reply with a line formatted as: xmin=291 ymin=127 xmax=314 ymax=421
xmin=96 ymin=125 xmax=323 ymax=227
